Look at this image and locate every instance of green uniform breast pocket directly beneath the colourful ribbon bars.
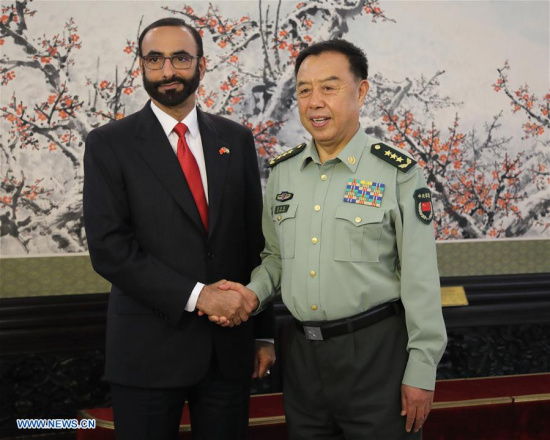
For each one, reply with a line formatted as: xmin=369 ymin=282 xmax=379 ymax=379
xmin=334 ymin=205 xmax=384 ymax=263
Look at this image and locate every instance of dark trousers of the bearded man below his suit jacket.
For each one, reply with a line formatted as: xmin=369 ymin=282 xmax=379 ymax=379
xmin=111 ymin=361 xmax=250 ymax=440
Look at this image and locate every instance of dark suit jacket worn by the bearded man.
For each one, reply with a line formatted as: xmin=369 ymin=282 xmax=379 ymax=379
xmin=84 ymin=103 xmax=271 ymax=387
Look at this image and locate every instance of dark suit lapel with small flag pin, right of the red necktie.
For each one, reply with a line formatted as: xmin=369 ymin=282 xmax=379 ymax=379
xmin=197 ymin=108 xmax=231 ymax=236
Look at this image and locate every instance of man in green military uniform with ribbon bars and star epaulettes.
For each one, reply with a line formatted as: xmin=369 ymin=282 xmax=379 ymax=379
xmin=211 ymin=40 xmax=446 ymax=440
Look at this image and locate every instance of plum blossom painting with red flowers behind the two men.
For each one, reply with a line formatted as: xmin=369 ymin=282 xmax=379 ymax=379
xmin=0 ymin=0 xmax=550 ymax=258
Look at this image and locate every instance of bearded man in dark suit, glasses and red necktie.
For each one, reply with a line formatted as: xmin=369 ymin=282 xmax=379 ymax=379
xmin=84 ymin=18 xmax=275 ymax=440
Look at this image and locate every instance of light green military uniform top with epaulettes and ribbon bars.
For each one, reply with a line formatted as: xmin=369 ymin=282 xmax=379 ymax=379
xmin=248 ymin=128 xmax=446 ymax=390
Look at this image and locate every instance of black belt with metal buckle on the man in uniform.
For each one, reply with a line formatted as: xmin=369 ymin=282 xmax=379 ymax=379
xmin=294 ymin=299 xmax=403 ymax=341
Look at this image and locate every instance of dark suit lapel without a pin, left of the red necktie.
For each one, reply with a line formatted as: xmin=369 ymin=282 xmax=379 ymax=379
xmin=136 ymin=102 xmax=205 ymax=231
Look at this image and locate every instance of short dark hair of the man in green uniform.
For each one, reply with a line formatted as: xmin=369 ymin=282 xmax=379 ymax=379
xmin=294 ymin=39 xmax=369 ymax=80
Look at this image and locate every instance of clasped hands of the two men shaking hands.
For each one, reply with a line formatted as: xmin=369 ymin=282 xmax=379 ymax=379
xmin=196 ymin=280 xmax=259 ymax=327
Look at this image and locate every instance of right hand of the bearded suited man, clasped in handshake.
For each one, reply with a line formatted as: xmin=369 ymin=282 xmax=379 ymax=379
xmin=196 ymin=280 xmax=257 ymax=327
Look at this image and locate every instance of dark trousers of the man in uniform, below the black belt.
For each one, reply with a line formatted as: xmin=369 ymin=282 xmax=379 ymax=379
xmin=283 ymin=313 xmax=421 ymax=440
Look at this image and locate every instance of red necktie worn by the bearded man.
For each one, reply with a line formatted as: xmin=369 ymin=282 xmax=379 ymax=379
xmin=174 ymin=122 xmax=208 ymax=231
